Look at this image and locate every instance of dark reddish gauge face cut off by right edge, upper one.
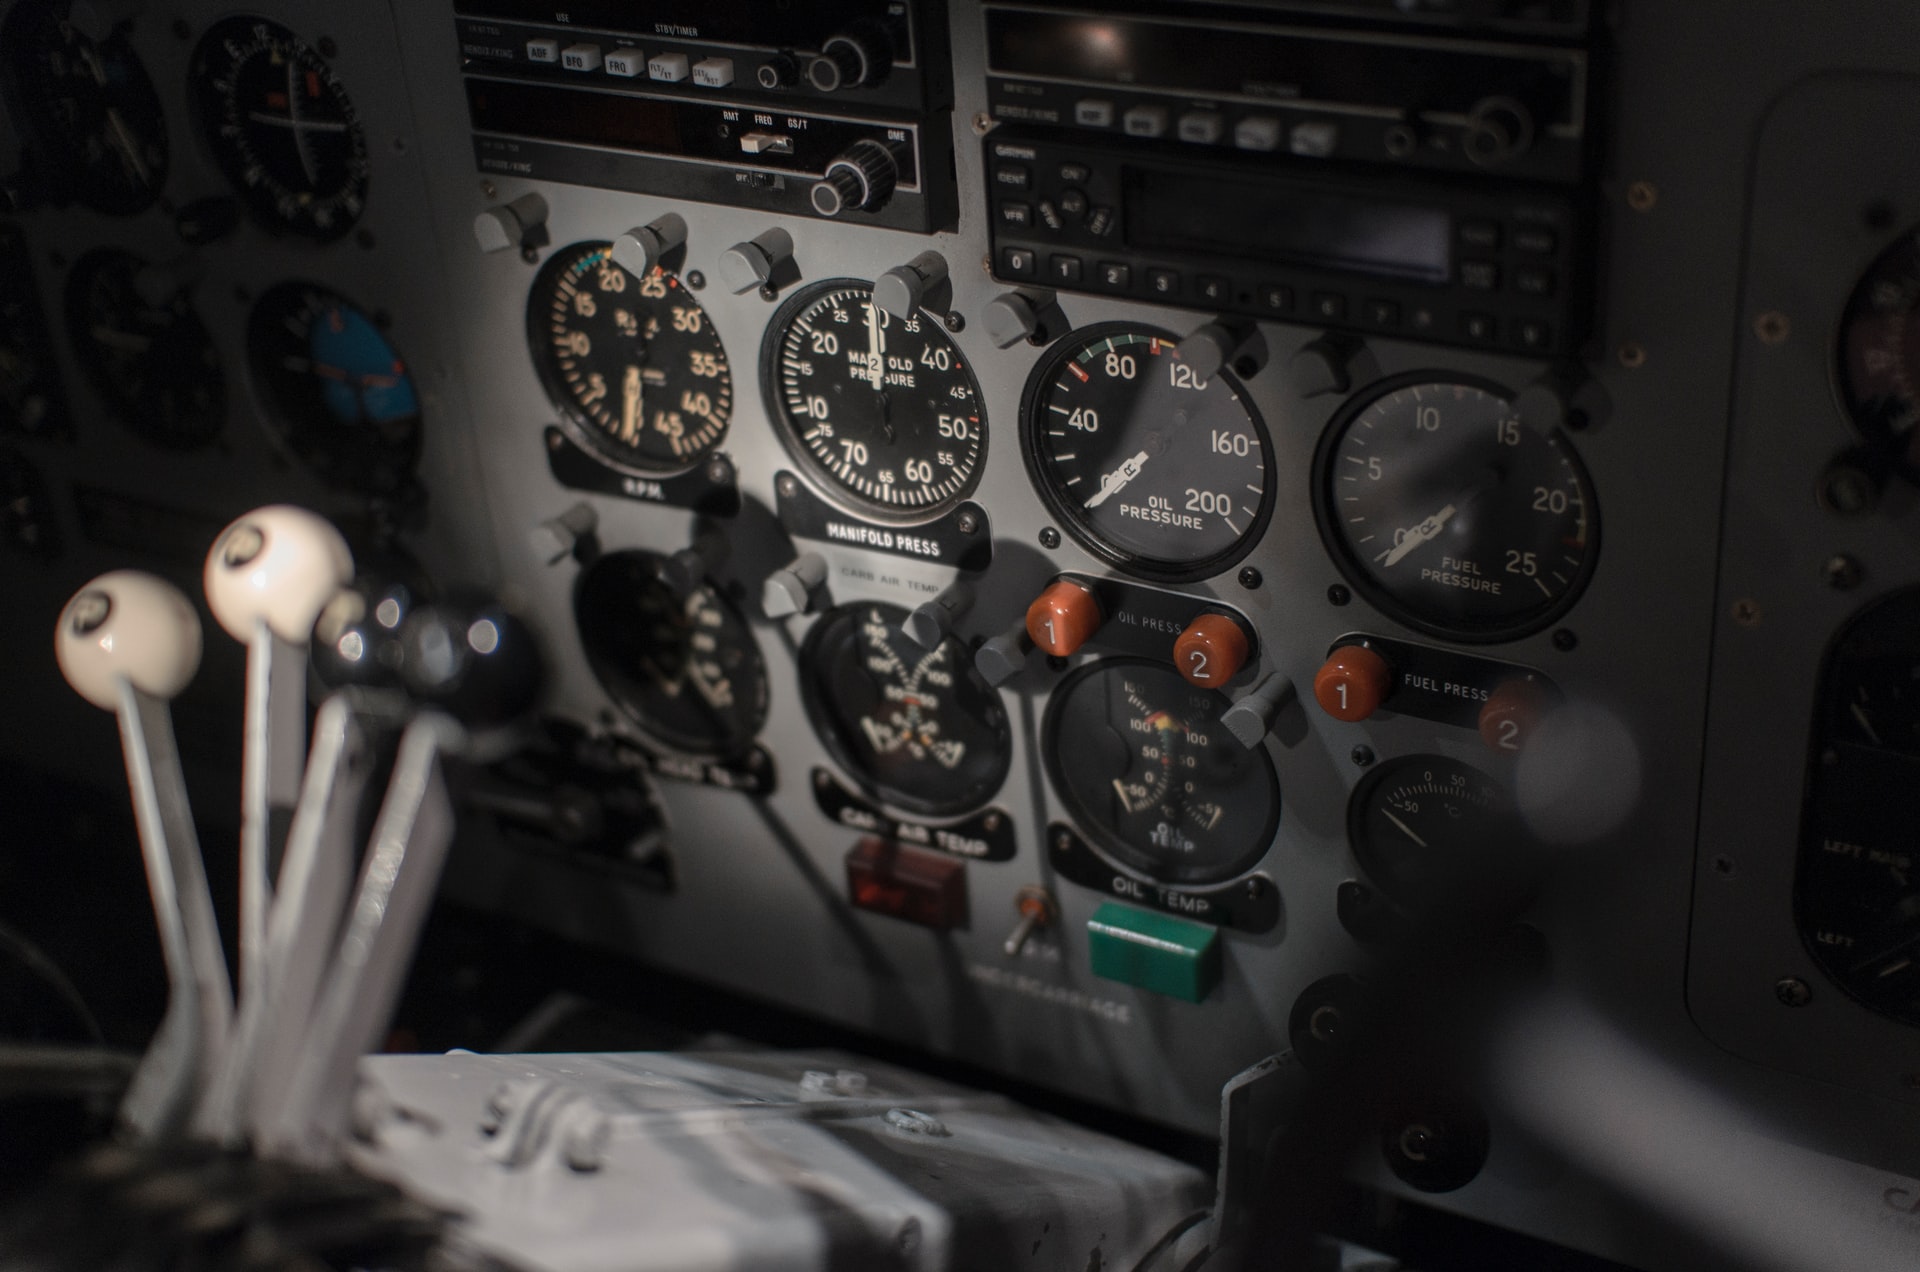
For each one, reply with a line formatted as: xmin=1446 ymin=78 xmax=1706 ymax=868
xmin=1837 ymin=231 xmax=1920 ymax=480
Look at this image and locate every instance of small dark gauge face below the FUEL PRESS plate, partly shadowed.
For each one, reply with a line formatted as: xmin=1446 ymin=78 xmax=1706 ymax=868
xmin=1348 ymin=755 xmax=1532 ymax=917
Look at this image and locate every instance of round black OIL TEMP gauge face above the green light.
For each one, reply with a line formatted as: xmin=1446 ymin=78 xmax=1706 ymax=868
xmin=1044 ymin=659 xmax=1281 ymax=884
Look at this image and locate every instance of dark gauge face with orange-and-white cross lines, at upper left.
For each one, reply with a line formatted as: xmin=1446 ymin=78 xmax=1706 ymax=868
xmin=192 ymin=15 xmax=372 ymax=242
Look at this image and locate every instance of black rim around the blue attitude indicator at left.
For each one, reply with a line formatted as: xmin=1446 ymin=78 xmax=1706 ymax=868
xmin=246 ymin=279 xmax=426 ymax=496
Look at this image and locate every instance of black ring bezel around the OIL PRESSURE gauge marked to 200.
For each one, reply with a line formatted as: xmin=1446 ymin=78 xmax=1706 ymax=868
xmin=1020 ymin=321 xmax=1281 ymax=582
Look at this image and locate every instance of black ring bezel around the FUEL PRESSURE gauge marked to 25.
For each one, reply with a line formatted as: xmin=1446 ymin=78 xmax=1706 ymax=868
xmin=1311 ymin=369 xmax=1601 ymax=646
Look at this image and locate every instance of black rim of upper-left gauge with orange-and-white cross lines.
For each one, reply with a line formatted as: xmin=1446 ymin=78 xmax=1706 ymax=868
xmin=186 ymin=12 xmax=372 ymax=244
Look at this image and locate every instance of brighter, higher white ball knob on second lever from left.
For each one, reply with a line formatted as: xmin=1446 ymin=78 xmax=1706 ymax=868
xmin=204 ymin=503 xmax=353 ymax=646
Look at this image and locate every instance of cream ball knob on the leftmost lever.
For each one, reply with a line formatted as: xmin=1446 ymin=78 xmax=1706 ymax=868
xmin=54 ymin=571 xmax=200 ymax=711
